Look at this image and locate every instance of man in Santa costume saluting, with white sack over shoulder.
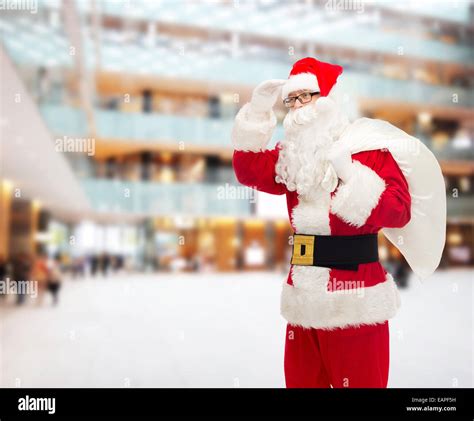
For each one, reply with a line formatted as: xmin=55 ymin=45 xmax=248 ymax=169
xmin=232 ymin=57 xmax=446 ymax=387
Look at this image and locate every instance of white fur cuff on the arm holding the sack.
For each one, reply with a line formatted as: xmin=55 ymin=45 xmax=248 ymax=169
xmin=331 ymin=161 xmax=386 ymax=227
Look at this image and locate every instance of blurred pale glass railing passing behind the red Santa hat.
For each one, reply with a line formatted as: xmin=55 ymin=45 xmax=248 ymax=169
xmin=0 ymin=17 xmax=474 ymax=107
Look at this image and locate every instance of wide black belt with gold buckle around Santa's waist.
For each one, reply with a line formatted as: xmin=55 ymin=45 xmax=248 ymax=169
xmin=291 ymin=234 xmax=379 ymax=270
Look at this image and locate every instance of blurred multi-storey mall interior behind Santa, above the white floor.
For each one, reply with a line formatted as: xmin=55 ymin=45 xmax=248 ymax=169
xmin=0 ymin=0 xmax=474 ymax=388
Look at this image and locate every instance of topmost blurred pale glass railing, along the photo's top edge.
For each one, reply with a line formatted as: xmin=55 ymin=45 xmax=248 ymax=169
xmin=68 ymin=0 xmax=473 ymax=62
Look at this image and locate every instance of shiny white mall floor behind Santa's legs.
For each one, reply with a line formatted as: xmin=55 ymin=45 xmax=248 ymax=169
xmin=0 ymin=270 xmax=474 ymax=387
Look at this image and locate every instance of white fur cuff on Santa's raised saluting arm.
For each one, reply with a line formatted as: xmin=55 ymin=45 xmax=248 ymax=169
xmin=232 ymin=103 xmax=277 ymax=152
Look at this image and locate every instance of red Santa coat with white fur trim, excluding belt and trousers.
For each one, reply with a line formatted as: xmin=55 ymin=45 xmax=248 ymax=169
xmin=233 ymin=138 xmax=411 ymax=329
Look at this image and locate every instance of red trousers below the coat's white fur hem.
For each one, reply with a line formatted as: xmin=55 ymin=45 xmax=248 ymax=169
xmin=285 ymin=321 xmax=389 ymax=388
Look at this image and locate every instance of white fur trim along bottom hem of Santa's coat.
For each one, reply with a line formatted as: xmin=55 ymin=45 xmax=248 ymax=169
xmin=281 ymin=273 xmax=400 ymax=329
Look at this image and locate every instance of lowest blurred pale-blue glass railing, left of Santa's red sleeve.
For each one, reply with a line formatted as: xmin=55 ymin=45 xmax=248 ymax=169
xmin=82 ymin=178 xmax=256 ymax=217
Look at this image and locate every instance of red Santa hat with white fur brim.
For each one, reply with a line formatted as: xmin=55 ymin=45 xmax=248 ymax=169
xmin=281 ymin=57 xmax=343 ymax=99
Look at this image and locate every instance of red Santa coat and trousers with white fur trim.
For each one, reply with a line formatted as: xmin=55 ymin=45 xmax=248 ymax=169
xmin=233 ymin=148 xmax=410 ymax=387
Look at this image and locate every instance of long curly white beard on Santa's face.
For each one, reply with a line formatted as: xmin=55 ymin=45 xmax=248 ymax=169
xmin=275 ymin=97 xmax=349 ymax=197
